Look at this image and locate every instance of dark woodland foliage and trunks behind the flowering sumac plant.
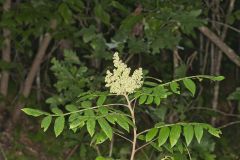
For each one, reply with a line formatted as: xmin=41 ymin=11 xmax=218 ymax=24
xmin=0 ymin=0 xmax=240 ymax=160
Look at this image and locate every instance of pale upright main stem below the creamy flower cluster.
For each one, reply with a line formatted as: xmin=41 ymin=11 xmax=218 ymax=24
xmin=124 ymin=95 xmax=137 ymax=160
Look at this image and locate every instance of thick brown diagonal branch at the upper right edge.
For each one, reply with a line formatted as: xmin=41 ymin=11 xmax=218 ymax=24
xmin=199 ymin=26 xmax=240 ymax=67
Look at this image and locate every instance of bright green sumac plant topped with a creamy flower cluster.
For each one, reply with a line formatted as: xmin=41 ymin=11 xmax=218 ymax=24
xmin=22 ymin=53 xmax=224 ymax=160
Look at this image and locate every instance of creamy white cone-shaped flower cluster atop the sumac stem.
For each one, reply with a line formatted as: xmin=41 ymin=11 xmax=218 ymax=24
xmin=105 ymin=52 xmax=143 ymax=95
